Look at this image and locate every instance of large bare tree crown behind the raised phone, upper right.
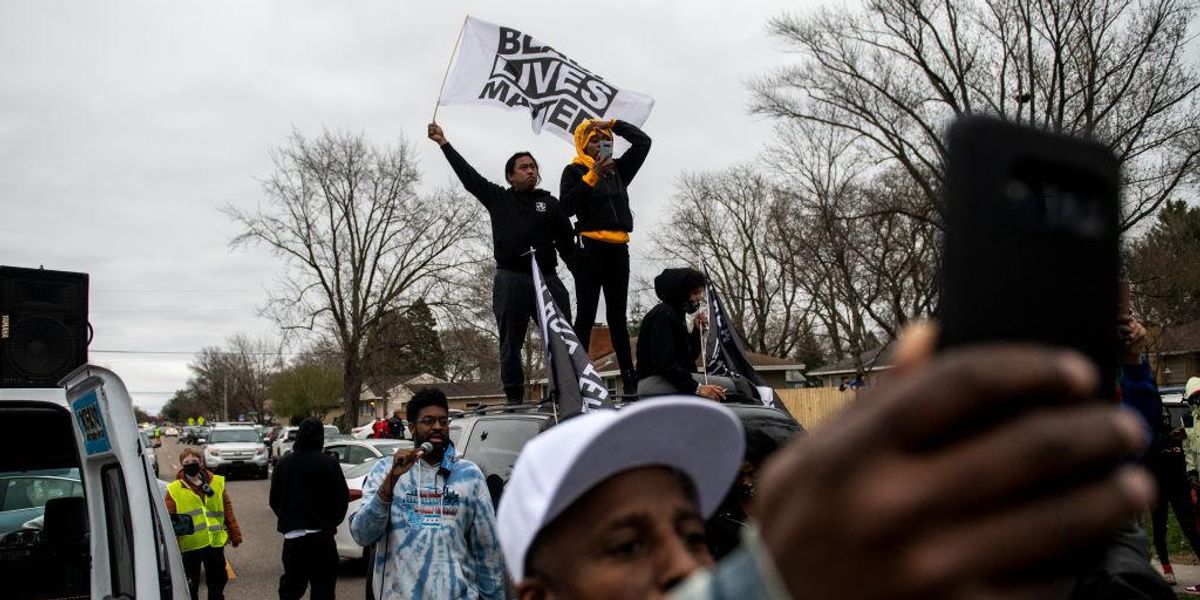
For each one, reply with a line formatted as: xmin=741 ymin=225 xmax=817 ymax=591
xmin=752 ymin=0 xmax=1200 ymax=229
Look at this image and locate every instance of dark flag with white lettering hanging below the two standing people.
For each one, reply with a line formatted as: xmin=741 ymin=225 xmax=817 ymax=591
xmin=529 ymin=254 xmax=612 ymax=418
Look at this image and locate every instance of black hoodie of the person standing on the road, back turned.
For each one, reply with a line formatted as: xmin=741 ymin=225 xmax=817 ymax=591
xmin=270 ymin=419 xmax=350 ymax=534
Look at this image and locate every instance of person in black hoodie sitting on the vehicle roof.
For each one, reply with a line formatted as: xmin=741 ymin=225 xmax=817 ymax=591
xmin=637 ymin=269 xmax=740 ymax=401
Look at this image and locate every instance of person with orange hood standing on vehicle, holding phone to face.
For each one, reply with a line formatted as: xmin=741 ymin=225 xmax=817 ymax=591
xmin=559 ymin=119 xmax=650 ymax=394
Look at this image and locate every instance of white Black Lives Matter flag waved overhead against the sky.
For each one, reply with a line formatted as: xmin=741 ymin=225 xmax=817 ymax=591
xmin=438 ymin=17 xmax=654 ymax=143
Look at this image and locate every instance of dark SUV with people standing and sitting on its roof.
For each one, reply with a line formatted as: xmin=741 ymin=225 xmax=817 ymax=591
xmin=450 ymin=400 xmax=804 ymax=506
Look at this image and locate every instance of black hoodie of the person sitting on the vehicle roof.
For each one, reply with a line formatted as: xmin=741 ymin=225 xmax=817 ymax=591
xmin=637 ymin=269 xmax=704 ymax=394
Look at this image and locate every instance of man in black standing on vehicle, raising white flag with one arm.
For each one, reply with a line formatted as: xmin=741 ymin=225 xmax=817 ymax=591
xmin=428 ymin=124 xmax=575 ymax=403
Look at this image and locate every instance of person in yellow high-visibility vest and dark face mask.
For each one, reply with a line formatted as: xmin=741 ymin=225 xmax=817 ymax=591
xmin=166 ymin=448 xmax=241 ymax=600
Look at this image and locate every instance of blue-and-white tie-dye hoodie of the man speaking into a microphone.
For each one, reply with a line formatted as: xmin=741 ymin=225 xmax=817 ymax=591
xmin=350 ymin=445 xmax=505 ymax=600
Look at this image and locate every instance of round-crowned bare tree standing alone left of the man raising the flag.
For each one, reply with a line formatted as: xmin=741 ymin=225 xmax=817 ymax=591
xmin=227 ymin=132 xmax=480 ymax=428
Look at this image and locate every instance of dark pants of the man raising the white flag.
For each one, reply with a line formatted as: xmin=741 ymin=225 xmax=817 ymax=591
xmin=492 ymin=269 xmax=571 ymax=402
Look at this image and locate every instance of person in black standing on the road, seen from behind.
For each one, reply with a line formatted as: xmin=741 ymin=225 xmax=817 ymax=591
xmin=270 ymin=418 xmax=350 ymax=600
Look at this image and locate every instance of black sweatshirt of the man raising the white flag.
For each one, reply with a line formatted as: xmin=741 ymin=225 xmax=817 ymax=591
xmin=442 ymin=144 xmax=575 ymax=272
